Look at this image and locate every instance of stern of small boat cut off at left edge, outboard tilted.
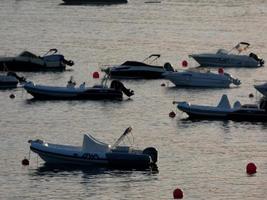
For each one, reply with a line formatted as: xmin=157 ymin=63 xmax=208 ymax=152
xmin=0 ymin=72 xmax=26 ymax=89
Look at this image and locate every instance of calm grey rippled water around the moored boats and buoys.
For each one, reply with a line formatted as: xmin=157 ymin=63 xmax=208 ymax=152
xmin=0 ymin=0 xmax=267 ymax=200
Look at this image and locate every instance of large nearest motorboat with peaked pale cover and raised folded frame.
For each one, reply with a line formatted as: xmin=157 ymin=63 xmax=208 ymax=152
xmin=28 ymin=127 xmax=158 ymax=168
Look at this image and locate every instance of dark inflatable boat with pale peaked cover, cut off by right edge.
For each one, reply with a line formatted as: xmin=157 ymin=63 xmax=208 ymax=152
xmin=173 ymin=94 xmax=267 ymax=121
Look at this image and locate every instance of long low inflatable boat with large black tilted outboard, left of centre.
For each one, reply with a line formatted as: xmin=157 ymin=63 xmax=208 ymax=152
xmin=24 ymin=77 xmax=134 ymax=100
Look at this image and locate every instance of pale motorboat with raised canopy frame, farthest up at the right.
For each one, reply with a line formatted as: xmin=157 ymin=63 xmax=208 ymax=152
xmin=192 ymin=42 xmax=264 ymax=68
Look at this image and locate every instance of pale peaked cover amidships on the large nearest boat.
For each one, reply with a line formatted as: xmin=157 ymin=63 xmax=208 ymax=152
xmin=82 ymin=134 xmax=110 ymax=153
